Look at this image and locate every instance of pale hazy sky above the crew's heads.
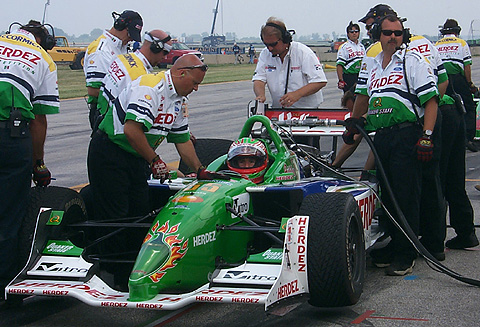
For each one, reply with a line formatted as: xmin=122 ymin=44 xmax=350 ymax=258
xmin=0 ymin=0 xmax=480 ymax=39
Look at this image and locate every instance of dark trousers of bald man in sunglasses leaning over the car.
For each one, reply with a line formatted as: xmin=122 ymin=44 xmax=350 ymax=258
xmin=87 ymin=131 xmax=149 ymax=284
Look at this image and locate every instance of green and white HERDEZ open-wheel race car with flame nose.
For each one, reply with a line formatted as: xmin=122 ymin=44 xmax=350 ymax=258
xmin=6 ymin=115 xmax=382 ymax=314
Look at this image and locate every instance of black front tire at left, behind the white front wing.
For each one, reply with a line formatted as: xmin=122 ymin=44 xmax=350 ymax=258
xmin=18 ymin=186 xmax=87 ymax=268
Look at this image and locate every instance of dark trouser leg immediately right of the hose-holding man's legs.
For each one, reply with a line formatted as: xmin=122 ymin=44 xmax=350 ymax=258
xmin=420 ymin=110 xmax=447 ymax=252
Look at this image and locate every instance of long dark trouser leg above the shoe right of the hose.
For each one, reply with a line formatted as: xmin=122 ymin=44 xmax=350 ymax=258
xmin=439 ymin=105 xmax=474 ymax=236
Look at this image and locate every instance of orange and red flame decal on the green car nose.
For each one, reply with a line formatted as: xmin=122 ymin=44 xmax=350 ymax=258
xmin=144 ymin=220 xmax=188 ymax=283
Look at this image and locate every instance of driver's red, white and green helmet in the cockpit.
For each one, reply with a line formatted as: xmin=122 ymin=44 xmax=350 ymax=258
xmin=227 ymin=137 xmax=268 ymax=183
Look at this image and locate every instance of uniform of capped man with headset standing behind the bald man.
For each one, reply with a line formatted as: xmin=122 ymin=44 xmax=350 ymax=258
xmin=83 ymin=30 xmax=127 ymax=129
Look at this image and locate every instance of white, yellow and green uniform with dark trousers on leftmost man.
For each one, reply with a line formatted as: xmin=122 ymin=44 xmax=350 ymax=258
xmin=0 ymin=30 xmax=59 ymax=291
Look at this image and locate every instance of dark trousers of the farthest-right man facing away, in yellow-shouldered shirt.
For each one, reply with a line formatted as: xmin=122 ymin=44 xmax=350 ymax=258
xmin=446 ymin=74 xmax=477 ymax=143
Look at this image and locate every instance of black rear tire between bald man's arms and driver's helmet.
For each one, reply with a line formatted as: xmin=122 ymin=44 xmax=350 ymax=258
xmin=178 ymin=139 xmax=233 ymax=174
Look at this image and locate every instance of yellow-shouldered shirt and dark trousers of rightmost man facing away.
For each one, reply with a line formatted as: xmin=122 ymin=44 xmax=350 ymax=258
xmin=435 ymin=34 xmax=476 ymax=140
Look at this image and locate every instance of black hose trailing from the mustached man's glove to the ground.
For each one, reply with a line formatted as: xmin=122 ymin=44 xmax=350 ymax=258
xmin=354 ymin=121 xmax=480 ymax=287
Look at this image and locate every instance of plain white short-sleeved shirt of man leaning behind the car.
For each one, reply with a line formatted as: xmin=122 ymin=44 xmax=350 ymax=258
xmin=252 ymin=42 xmax=327 ymax=108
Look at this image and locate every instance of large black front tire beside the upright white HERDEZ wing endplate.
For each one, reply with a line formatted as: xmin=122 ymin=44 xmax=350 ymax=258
xmin=299 ymin=193 xmax=366 ymax=307
